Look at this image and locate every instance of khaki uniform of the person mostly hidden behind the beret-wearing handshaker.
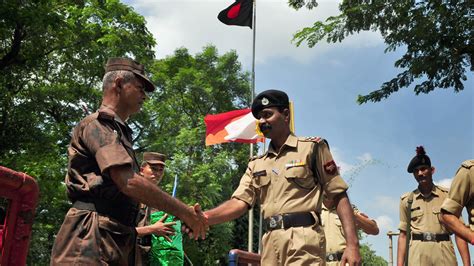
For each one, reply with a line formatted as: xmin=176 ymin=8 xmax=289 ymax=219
xmin=321 ymin=204 xmax=359 ymax=266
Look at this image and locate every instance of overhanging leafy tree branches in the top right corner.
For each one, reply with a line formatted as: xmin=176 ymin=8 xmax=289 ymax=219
xmin=288 ymin=0 xmax=474 ymax=104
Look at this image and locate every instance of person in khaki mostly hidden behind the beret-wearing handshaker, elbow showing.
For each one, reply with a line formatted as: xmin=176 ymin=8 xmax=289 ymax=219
xmin=321 ymin=197 xmax=379 ymax=266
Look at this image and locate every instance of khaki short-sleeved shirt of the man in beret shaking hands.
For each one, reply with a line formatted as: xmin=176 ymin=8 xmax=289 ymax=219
xmin=232 ymin=134 xmax=348 ymax=218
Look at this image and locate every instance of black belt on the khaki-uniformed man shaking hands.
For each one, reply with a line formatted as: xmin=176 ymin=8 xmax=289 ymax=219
xmin=264 ymin=212 xmax=316 ymax=231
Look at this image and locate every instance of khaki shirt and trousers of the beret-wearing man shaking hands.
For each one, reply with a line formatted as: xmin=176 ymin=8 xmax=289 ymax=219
xmin=232 ymin=135 xmax=348 ymax=265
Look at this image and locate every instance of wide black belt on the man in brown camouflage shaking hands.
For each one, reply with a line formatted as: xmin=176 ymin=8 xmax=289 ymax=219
xmin=72 ymin=199 xmax=138 ymax=226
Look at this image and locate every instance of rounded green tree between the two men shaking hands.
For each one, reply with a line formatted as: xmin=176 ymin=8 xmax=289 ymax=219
xmin=133 ymin=46 xmax=258 ymax=265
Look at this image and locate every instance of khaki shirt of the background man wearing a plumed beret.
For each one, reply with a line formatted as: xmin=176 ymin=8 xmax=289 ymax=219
xmin=398 ymin=185 xmax=449 ymax=234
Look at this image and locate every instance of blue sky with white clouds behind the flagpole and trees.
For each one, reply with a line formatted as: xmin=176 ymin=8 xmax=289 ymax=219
xmin=125 ymin=0 xmax=474 ymax=260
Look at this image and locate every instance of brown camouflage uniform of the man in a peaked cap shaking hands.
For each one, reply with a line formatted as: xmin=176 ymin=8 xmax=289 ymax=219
xmin=51 ymin=108 xmax=138 ymax=265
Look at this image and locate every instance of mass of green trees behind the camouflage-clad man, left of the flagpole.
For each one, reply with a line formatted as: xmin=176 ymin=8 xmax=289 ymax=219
xmin=0 ymin=0 xmax=388 ymax=265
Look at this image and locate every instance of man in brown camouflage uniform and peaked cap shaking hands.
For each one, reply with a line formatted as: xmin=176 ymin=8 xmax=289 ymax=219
xmin=51 ymin=58 xmax=207 ymax=265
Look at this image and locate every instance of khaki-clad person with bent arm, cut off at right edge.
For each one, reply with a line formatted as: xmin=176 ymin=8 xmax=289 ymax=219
xmin=441 ymin=160 xmax=474 ymax=245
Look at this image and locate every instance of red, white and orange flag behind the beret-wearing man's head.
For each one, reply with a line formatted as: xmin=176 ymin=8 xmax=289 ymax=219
xmin=204 ymin=108 xmax=264 ymax=146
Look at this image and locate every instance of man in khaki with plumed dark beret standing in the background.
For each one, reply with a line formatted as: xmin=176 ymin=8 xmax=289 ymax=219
xmin=397 ymin=146 xmax=471 ymax=266
